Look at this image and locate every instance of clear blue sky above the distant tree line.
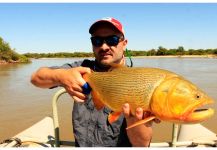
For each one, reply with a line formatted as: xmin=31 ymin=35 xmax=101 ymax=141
xmin=0 ymin=2 xmax=217 ymax=54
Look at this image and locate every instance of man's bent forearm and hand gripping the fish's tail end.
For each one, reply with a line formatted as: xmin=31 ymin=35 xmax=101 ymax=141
xmin=31 ymin=67 xmax=91 ymax=102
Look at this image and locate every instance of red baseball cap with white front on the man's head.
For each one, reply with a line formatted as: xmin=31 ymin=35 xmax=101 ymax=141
xmin=89 ymin=17 xmax=124 ymax=35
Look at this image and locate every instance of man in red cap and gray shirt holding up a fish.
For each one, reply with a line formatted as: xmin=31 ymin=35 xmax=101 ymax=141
xmin=31 ymin=18 xmax=152 ymax=147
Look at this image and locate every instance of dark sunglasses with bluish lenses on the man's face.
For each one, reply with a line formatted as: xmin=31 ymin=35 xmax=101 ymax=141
xmin=90 ymin=35 xmax=123 ymax=47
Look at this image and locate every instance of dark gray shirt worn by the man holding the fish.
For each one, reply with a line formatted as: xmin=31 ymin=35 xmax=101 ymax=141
xmin=52 ymin=59 xmax=132 ymax=147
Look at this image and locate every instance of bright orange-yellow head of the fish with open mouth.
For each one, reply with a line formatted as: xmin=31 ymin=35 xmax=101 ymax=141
xmin=150 ymin=76 xmax=214 ymax=123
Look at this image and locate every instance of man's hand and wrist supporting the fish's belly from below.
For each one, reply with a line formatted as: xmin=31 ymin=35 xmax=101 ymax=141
xmin=123 ymin=103 xmax=160 ymax=147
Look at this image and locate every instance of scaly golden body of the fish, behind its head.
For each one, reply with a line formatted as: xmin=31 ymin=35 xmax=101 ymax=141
xmin=89 ymin=68 xmax=175 ymax=113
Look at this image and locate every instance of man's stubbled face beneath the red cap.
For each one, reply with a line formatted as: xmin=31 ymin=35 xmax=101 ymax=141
xmin=92 ymin=25 xmax=127 ymax=67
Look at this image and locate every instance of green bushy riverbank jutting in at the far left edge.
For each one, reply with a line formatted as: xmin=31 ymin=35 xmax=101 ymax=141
xmin=0 ymin=37 xmax=29 ymax=63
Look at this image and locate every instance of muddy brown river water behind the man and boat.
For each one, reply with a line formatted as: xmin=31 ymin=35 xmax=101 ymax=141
xmin=0 ymin=58 xmax=217 ymax=142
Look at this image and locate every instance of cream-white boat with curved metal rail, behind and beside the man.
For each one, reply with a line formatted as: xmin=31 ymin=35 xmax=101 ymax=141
xmin=0 ymin=89 xmax=217 ymax=148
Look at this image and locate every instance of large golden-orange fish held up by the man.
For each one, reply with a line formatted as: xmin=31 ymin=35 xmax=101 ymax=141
xmin=84 ymin=67 xmax=214 ymax=129
